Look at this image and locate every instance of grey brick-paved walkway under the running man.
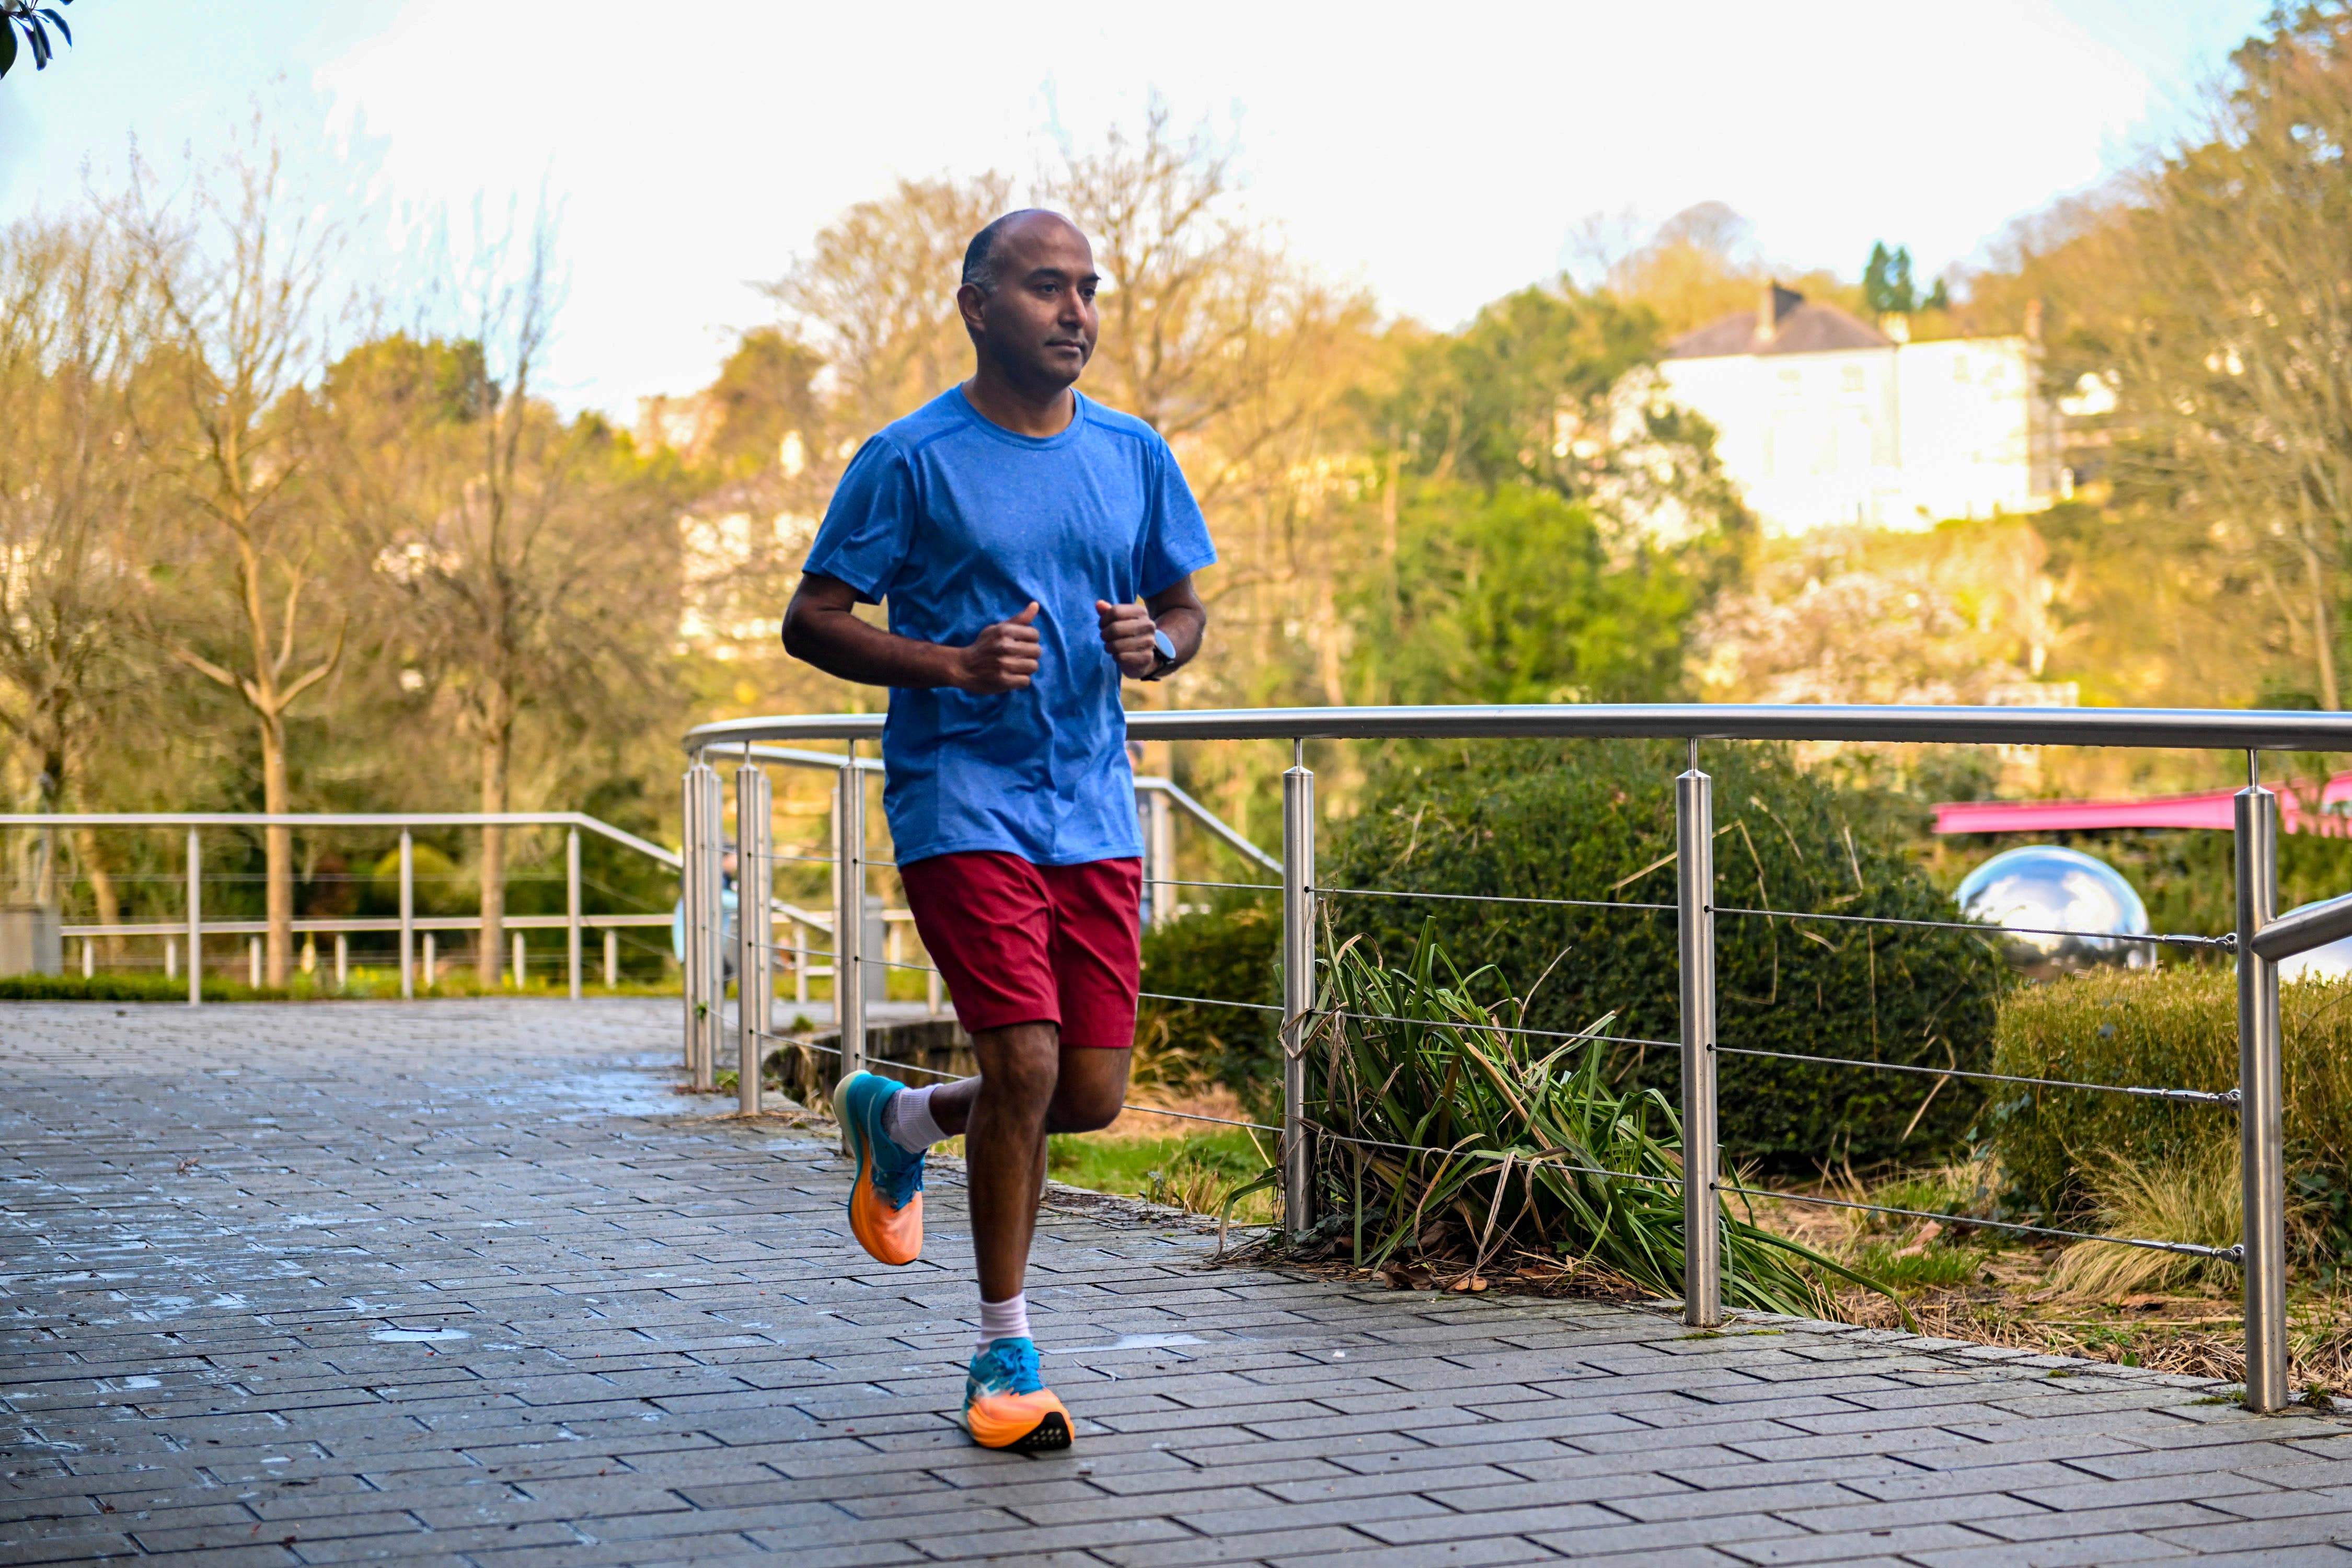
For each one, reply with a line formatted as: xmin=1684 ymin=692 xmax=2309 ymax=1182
xmin=0 ymin=1001 xmax=2352 ymax=1568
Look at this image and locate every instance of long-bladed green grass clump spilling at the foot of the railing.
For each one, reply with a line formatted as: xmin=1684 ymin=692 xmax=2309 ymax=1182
xmin=1308 ymin=929 xmax=1880 ymax=1317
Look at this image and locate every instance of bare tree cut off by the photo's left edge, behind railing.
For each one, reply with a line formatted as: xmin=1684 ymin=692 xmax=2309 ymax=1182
xmin=0 ymin=218 xmax=153 ymax=924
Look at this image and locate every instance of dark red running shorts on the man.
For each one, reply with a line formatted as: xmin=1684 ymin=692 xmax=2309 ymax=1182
xmin=898 ymin=849 xmax=1143 ymax=1048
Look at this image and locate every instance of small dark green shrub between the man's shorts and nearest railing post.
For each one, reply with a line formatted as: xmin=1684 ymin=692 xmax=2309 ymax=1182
xmin=1136 ymin=893 xmax=1282 ymax=1121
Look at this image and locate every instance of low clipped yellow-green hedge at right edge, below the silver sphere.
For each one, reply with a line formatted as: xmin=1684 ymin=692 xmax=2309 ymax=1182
xmin=1985 ymin=969 xmax=2352 ymax=1241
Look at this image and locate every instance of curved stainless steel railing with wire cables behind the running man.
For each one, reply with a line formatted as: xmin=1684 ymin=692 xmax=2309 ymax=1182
xmin=685 ymin=703 xmax=2352 ymax=1411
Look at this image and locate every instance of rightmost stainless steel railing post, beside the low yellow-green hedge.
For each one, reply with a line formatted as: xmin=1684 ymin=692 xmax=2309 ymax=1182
xmin=2237 ymin=771 xmax=2286 ymax=1411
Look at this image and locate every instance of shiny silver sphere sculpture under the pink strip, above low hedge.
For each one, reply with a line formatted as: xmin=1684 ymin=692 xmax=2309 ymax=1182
xmin=1955 ymin=844 xmax=2157 ymax=981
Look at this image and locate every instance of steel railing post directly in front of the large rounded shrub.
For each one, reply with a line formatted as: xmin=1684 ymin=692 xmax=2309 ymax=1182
xmin=1675 ymin=741 xmax=1724 ymax=1328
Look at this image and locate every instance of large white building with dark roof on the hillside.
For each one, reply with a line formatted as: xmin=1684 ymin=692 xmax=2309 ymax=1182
xmin=1658 ymin=284 xmax=2068 ymax=534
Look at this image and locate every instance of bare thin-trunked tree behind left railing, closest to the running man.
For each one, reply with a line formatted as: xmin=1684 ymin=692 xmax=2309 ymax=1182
xmin=320 ymin=218 xmax=677 ymax=985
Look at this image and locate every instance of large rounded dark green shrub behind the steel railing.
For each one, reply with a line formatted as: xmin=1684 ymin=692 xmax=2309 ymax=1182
xmin=1322 ymin=741 xmax=2009 ymax=1168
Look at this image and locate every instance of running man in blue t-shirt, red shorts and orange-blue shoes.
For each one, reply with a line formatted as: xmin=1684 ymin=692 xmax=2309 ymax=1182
xmin=783 ymin=212 xmax=1216 ymax=1450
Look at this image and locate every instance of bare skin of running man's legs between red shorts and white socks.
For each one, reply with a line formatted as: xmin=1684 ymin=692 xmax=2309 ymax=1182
xmin=931 ymin=1023 xmax=1132 ymax=1302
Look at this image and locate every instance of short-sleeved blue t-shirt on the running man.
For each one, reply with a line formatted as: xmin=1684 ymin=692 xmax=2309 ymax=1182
xmin=807 ymin=388 xmax=1216 ymax=865
